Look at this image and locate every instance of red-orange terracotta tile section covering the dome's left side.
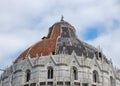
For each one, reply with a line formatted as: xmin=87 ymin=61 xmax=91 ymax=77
xmin=14 ymin=24 xmax=60 ymax=63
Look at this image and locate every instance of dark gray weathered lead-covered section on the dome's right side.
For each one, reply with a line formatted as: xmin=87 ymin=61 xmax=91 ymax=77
xmin=56 ymin=27 xmax=95 ymax=58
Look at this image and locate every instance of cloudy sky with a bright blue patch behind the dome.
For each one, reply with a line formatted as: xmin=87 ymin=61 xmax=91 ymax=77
xmin=0 ymin=0 xmax=120 ymax=73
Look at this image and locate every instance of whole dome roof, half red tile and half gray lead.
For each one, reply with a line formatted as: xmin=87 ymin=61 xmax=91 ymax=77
xmin=15 ymin=20 xmax=103 ymax=62
